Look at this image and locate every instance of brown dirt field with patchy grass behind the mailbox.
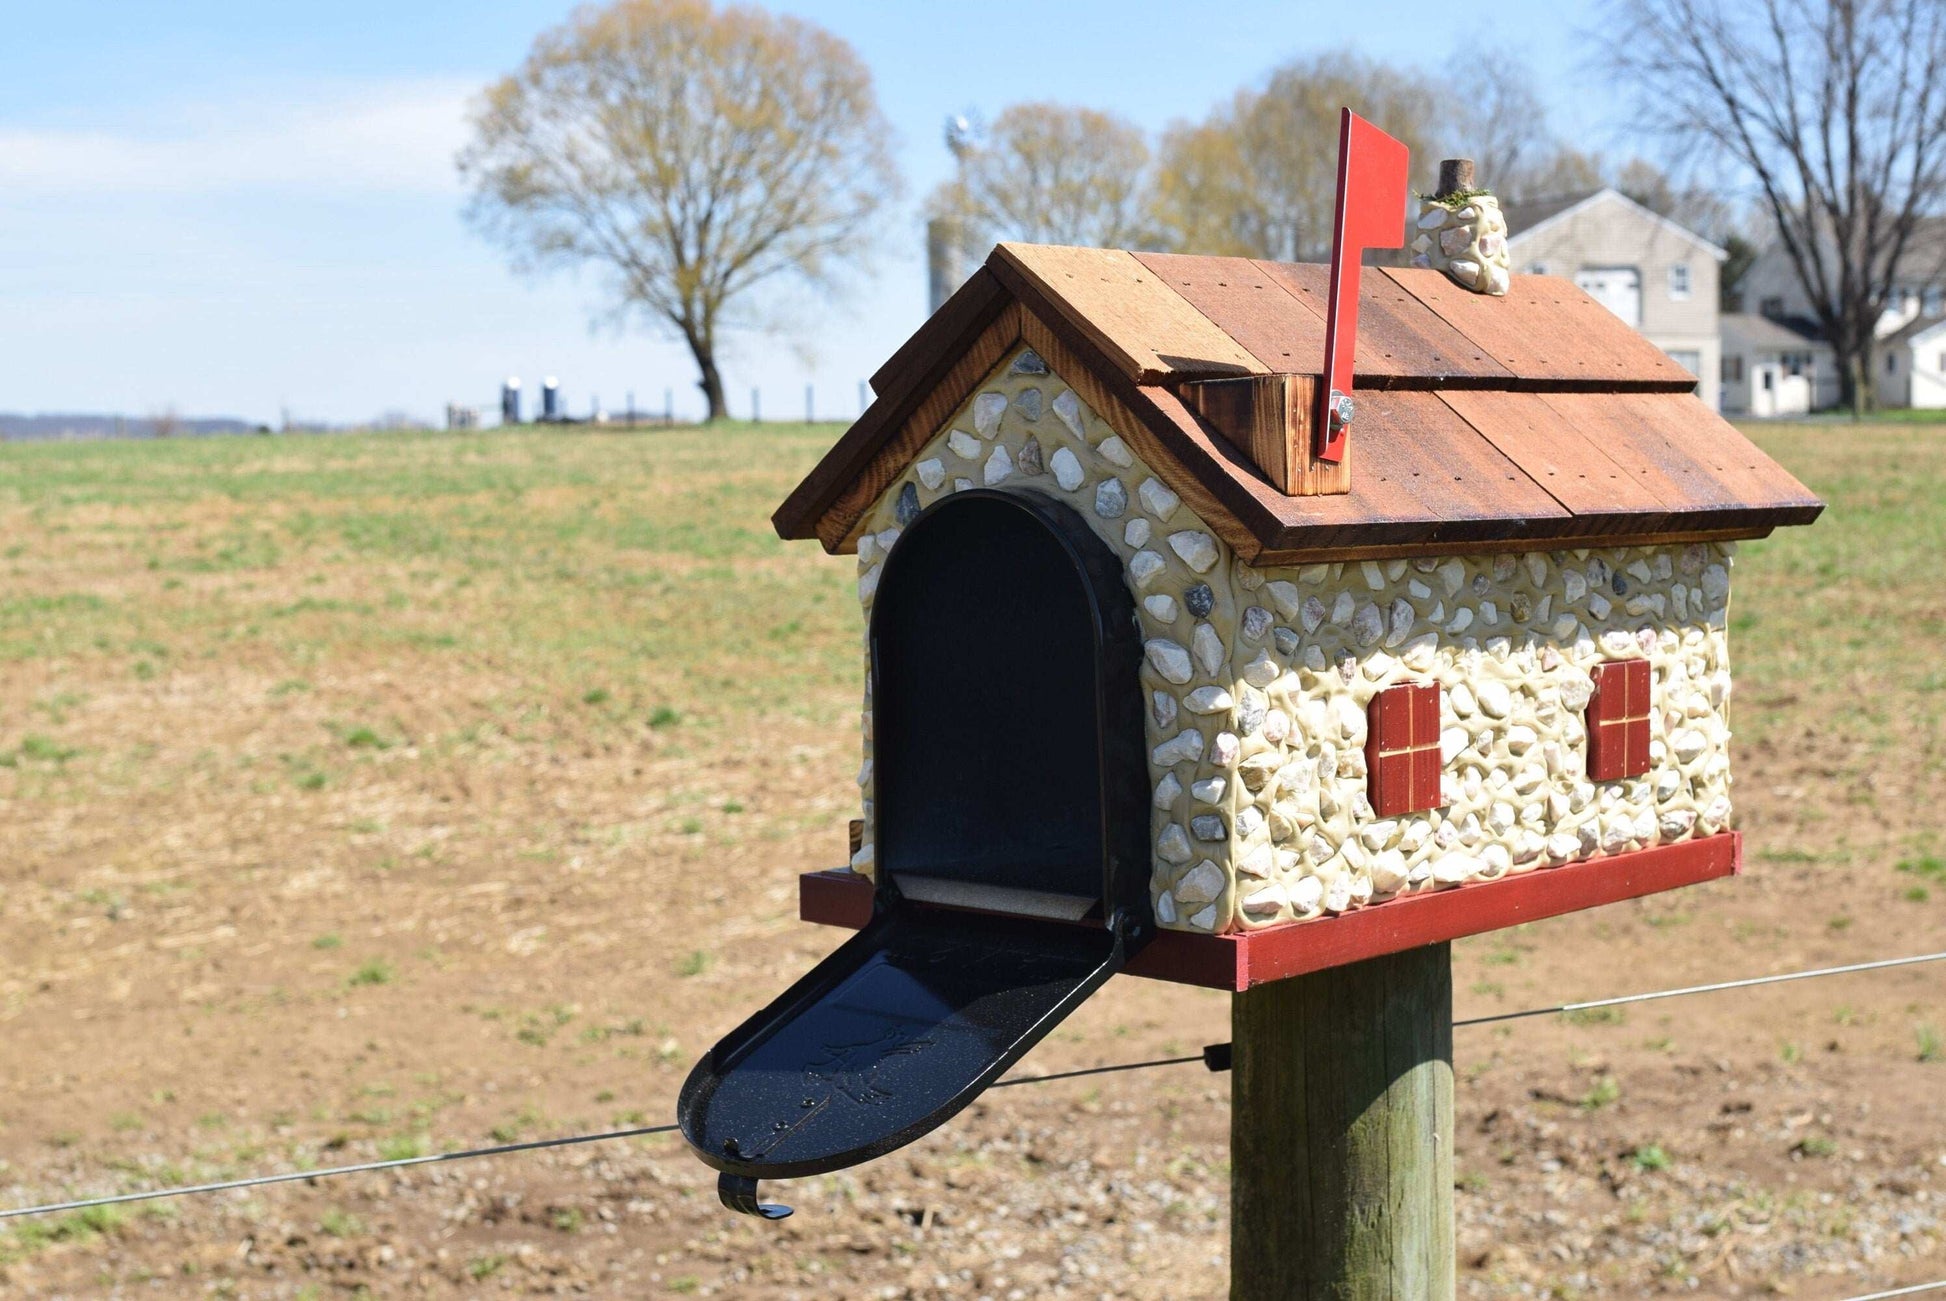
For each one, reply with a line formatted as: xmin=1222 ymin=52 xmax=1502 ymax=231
xmin=0 ymin=426 xmax=1946 ymax=1301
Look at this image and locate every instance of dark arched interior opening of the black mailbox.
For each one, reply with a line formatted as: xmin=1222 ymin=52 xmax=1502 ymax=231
xmin=872 ymin=492 xmax=1148 ymax=924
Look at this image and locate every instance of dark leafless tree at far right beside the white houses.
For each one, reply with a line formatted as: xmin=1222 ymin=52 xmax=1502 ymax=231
xmin=1611 ymin=0 xmax=1946 ymax=414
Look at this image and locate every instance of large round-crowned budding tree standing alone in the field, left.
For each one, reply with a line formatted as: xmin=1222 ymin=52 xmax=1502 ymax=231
xmin=459 ymin=0 xmax=899 ymax=420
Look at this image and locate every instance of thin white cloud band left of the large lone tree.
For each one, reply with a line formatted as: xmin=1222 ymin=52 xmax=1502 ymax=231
xmin=0 ymin=78 xmax=481 ymax=198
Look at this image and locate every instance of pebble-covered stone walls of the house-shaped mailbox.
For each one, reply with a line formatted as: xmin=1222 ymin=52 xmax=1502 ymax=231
xmin=852 ymin=348 xmax=1734 ymax=932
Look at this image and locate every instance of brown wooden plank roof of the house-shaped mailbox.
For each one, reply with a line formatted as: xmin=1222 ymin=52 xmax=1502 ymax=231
xmin=773 ymin=243 xmax=1823 ymax=564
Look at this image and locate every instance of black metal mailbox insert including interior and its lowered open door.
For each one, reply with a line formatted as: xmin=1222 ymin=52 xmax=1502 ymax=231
xmin=677 ymin=490 xmax=1154 ymax=1217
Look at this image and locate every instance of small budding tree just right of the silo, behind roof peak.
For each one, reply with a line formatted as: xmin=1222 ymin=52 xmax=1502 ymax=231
xmin=928 ymin=103 xmax=1148 ymax=247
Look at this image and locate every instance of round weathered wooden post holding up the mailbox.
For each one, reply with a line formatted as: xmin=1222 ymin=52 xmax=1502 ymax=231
xmin=1230 ymin=943 xmax=1456 ymax=1301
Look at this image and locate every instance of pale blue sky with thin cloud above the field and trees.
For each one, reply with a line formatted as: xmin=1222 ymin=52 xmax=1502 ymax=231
xmin=0 ymin=0 xmax=1621 ymax=422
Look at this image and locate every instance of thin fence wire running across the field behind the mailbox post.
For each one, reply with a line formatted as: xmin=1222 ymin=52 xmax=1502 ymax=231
xmin=0 ymin=951 xmax=1946 ymax=1229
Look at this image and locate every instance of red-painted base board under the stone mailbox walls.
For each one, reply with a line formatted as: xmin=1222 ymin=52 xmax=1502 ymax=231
xmin=798 ymin=830 xmax=1744 ymax=992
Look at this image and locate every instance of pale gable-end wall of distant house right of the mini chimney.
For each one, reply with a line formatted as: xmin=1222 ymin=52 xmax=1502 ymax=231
xmin=1508 ymin=191 xmax=1722 ymax=408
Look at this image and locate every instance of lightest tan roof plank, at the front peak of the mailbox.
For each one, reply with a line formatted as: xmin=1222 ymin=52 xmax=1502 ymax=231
xmin=987 ymin=243 xmax=1269 ymax=383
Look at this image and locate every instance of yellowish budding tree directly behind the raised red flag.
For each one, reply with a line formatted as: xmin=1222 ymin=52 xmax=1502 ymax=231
xmin=1154 ymin=51 xmax=1444 ymax=261
